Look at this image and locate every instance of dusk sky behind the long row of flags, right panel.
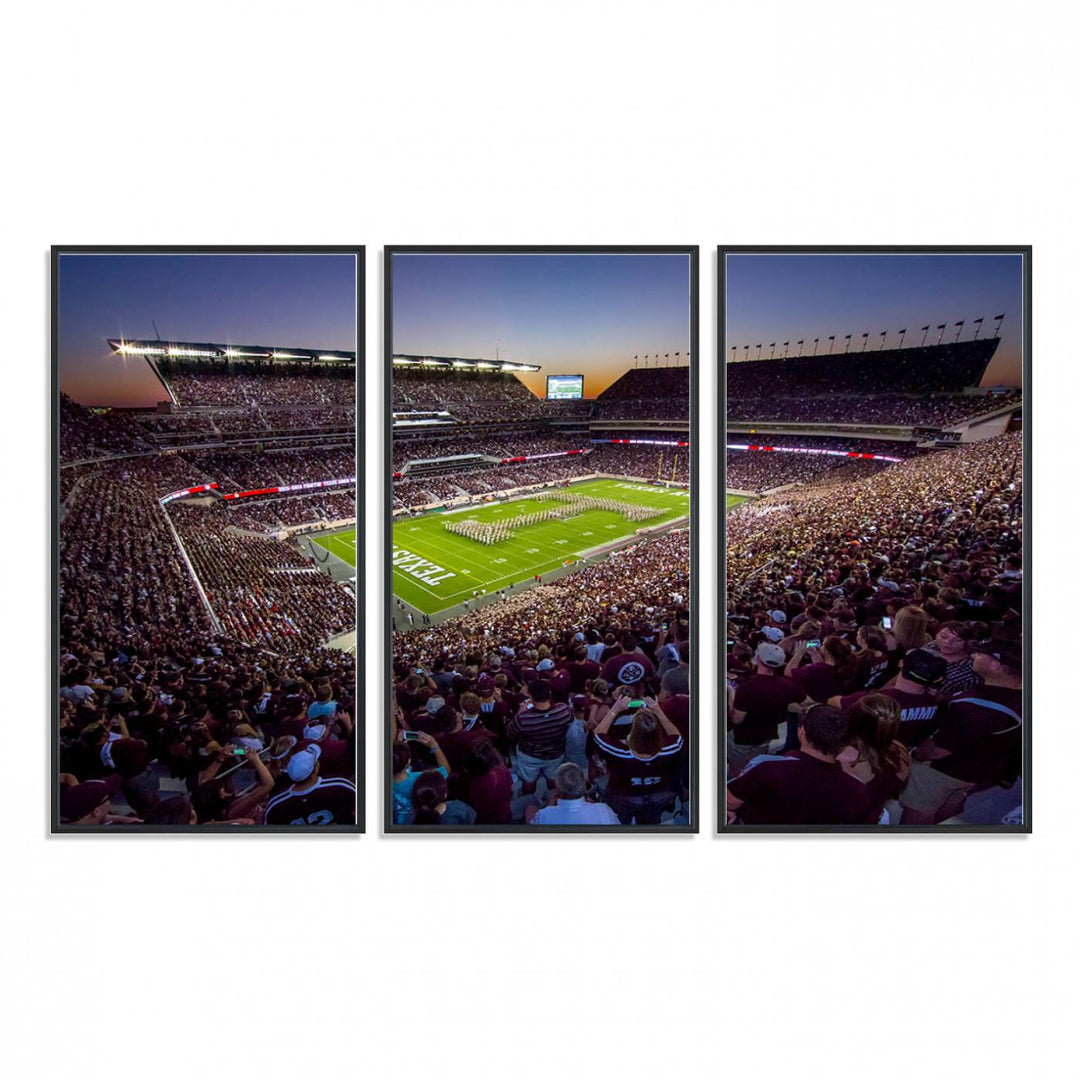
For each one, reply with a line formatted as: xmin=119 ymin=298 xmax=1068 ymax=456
xmin=724 ymin=254 xmax=1024 ymax=386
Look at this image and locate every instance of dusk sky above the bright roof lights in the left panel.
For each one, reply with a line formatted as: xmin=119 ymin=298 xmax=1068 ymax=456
xmin=58 ymin=254 xmax=356 ymax=406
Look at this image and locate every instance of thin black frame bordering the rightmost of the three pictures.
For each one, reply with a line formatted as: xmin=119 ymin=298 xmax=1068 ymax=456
xmin=716 ymin=244 xmax=1031 ymax=838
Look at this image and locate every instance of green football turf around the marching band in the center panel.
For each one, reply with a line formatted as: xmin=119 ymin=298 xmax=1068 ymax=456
xmin=393 ymin=480 xmax=690 ymax=615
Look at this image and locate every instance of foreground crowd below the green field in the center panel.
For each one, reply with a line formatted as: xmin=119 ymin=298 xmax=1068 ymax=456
xmin=392 ymin=530 xmax=690 ymax=826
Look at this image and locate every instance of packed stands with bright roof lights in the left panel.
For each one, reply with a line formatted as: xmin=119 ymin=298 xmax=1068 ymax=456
xmin=57 ymin=341 xmax=356 ymax=826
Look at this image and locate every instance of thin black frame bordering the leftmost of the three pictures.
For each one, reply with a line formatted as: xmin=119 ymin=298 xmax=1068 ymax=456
xmin=46 ymin=244 xmax=366 ymax=837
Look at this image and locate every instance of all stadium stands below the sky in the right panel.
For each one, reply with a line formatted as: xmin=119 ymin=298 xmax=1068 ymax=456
xmin=726 ymin=327 xmax=1024 ymax=826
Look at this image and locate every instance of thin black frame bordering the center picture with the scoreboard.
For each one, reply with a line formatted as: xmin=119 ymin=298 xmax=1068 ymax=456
xmin=379 ymin=244 xmax=701 ymax=837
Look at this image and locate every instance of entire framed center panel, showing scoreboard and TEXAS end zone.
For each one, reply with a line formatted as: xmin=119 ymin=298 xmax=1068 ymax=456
xmin=386 ymin=247 xmax=697 ymax=832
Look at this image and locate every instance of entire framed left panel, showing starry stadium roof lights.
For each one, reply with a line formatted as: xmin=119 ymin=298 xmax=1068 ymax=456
xmin=51 ymin=247 xmax=364 ymax=833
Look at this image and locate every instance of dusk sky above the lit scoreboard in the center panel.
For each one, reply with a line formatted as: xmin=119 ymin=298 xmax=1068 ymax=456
xmin=393 ymin=254 xmax=690 ymax=397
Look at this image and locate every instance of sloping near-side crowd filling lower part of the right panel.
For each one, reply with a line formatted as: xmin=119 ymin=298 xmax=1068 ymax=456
xmin=726 ymin=432 xmax=1024 ymax=825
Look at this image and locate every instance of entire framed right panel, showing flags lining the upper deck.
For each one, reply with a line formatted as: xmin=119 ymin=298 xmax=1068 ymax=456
xmin=718 ymin=246 xmax=1031 ymax=834
